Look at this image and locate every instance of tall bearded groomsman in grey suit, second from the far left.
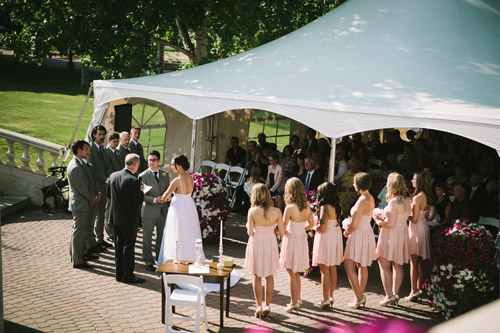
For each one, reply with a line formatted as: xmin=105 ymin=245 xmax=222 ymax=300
xmin=89 ymin=125 xmax=112 ymax=251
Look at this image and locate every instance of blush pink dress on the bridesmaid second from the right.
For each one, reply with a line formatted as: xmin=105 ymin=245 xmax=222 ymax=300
xmin=377 ymin=206 xmax=410 ymax=265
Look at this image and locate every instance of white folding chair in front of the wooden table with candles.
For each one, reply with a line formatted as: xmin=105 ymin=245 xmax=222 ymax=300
xmin=163 ymin=273 xmax=208 ymax=333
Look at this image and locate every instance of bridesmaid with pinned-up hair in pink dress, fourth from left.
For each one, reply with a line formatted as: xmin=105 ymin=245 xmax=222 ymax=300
xmin=344 ymin=172 xmax=377 ymax=309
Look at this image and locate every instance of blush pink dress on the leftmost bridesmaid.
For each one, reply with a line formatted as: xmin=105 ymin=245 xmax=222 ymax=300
xmin=245 ymin=225 xmax=279 ymax=277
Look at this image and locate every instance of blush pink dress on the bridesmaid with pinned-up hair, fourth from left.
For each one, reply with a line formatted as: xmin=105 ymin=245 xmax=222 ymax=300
xmin=344 ymin=210 xmax=377 ymax=267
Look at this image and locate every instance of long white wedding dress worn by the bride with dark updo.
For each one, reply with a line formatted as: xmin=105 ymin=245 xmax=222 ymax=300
xmin=156 ymin=176 xmax=206 ymax=267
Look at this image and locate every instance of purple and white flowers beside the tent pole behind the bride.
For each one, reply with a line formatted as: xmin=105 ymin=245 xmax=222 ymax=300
xmin=191 ymin=173 xmax=229 ymax=239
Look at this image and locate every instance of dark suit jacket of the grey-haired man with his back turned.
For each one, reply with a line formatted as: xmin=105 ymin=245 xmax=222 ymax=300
xmin=108 ymin=169 xmax=144 ymax=237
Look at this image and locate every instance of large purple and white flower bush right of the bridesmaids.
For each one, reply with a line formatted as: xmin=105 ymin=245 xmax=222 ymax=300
xmin=424 ymin=219 xmax=498 ymax=319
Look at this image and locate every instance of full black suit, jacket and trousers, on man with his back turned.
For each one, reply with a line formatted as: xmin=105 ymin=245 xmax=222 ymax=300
xmin=108 ymin=169 xmax=144 ymax=282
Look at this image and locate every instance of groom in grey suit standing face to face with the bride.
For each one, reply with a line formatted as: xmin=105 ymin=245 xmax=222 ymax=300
xmin=139 ymin=150 xmax=170 ymax=272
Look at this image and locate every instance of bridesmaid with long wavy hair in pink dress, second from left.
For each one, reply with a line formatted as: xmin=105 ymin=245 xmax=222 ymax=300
xmin=280 ymin=177 xmax=314 ymax=313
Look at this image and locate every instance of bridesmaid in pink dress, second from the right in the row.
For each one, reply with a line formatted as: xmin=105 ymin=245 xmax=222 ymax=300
xmin=376 ymin=172 xmax=411 ymax=306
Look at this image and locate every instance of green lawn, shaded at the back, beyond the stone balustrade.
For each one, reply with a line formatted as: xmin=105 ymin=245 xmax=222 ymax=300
xmin=0 ymin=61 xmax=99 ymax=166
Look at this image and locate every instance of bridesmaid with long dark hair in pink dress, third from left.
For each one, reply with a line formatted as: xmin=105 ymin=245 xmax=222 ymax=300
xmin=312 ymin=183 xmax=344 ymax=309
